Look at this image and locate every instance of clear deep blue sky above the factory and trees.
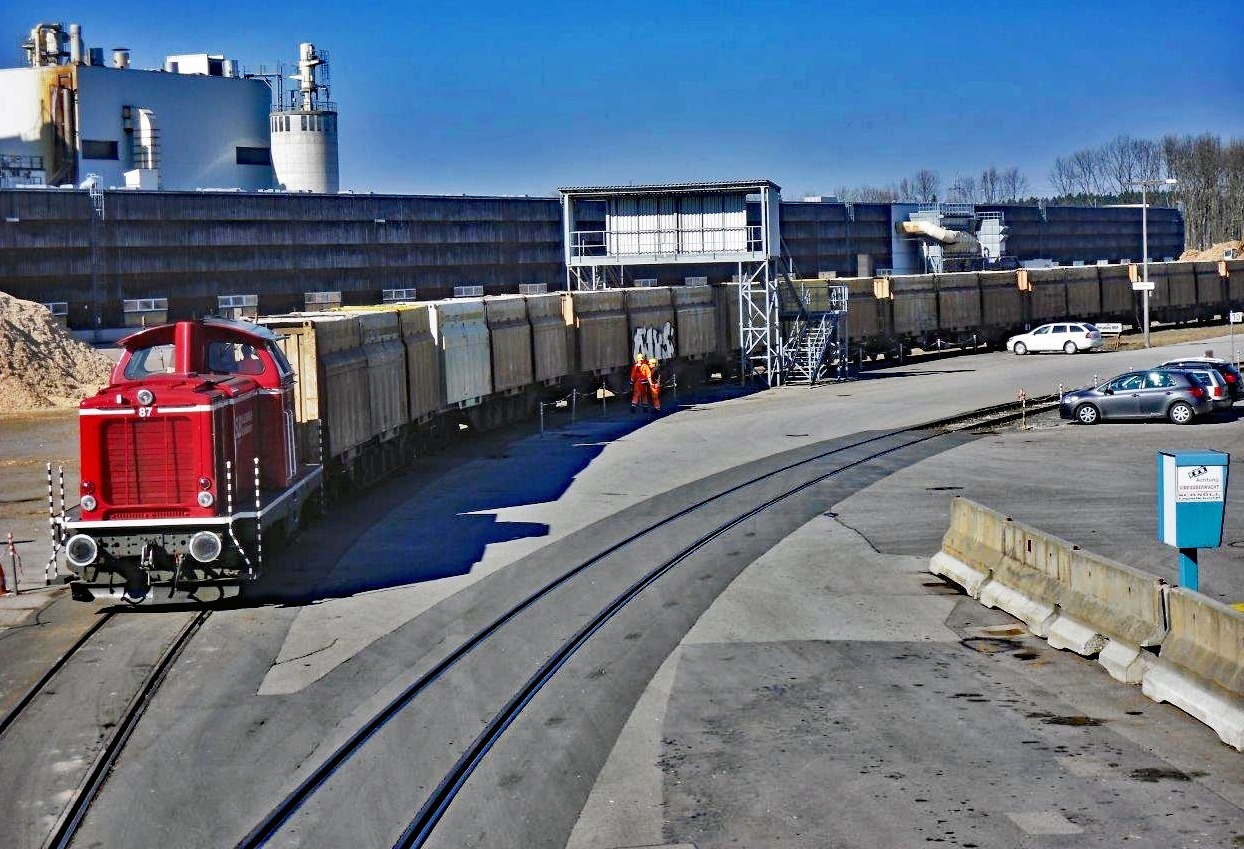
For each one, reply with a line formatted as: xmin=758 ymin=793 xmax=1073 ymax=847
xmin=0 ymin=0 xmax=1244 ymax=198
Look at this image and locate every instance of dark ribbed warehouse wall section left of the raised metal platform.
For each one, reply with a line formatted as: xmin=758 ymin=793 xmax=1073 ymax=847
xmin=0 ymin=190 xmax=565 ymax=326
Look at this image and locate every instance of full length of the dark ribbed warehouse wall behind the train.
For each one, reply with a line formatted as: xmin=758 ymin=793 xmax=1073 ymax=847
xmin=0 ymin=189 xmax=1183 ymax=326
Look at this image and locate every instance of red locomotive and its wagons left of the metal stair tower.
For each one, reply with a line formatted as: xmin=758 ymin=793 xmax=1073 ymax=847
xmin=53 ymin=286 xmax=738 ymax=604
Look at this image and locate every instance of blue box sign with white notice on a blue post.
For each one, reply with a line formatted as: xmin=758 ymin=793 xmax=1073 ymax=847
xmin=1157 ymin=451 xmax=1232 ymax=591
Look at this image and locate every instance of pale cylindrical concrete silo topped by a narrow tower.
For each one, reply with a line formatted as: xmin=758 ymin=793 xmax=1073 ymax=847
xmin=271 ymin=42 xmax=340 ymax=194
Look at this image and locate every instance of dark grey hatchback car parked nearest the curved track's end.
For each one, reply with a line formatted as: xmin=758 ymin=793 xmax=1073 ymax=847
xmin=1059 ymin=368 xmax=1214 ymax=425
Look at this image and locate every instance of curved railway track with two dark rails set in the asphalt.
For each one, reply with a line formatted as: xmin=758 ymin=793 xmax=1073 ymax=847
xmin=236 ymin=396 xmax=1039 ymax=849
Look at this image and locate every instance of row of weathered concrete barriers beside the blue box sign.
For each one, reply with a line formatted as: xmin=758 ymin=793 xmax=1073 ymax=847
xmin=929 ymin=498 xmax=1244 ymax=751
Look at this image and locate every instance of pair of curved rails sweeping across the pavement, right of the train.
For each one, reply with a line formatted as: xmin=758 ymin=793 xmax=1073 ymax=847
xmin=236 ymin=398 xmax=1056 ymax=849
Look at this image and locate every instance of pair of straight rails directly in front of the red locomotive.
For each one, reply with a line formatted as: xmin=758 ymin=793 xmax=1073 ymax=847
xmin=0 ymin=610 xmax=211 ymax=849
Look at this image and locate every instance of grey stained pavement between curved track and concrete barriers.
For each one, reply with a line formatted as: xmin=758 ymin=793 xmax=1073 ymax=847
xmin=567 ymin=510 xmax=1244 ymax=849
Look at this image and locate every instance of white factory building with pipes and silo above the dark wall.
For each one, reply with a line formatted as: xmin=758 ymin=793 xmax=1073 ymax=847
xmin=0 ymin=24 xmax=340 ymax=194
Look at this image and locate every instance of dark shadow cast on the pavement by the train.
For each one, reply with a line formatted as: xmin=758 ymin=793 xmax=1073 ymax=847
xmin=245 ymin=386 xmax=756 ymax=605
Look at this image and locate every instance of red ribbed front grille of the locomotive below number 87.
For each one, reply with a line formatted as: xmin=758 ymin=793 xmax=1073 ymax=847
xmin=102 ymin=416 xmax=195 ymax=505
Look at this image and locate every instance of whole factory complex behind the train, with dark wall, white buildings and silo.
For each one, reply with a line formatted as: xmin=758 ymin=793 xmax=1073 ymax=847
xmin=0 ymin=24 xmax=1183 ymax=326
